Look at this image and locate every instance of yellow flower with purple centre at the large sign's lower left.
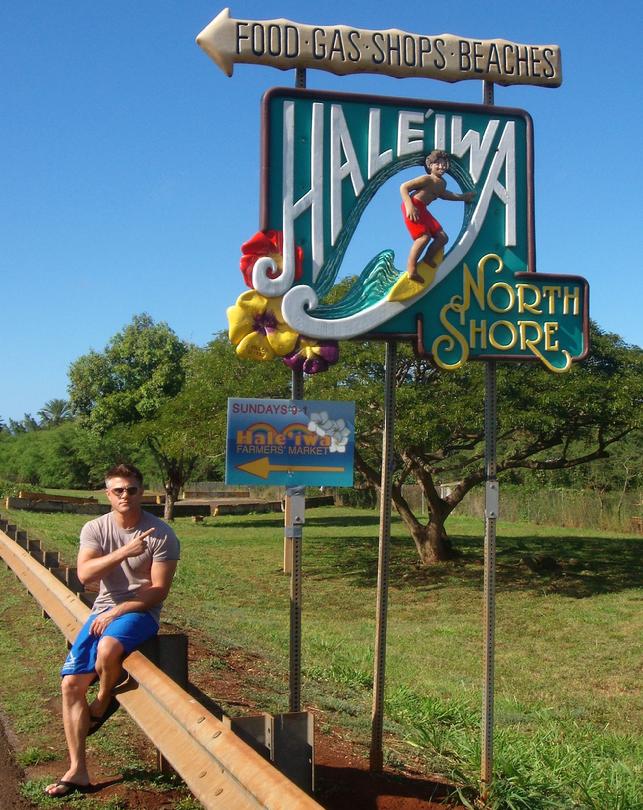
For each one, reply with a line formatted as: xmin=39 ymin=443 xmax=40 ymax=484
xmin=227 ymin=290 xmax=299 ymax=360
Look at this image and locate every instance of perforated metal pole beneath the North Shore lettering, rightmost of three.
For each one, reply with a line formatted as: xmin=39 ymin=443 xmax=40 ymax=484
xmin=480 ymin=81 xmax=499 ymax=798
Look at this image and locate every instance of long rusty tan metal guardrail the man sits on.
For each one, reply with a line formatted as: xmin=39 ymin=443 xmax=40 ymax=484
xmin=0 ymin=527 xmax=321 ymax=810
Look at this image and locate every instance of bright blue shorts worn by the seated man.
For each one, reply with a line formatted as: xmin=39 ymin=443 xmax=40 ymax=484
xmin=60 ymin=612 xmax=159 ymax=676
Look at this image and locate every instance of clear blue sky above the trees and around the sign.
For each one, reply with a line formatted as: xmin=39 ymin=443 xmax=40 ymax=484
xmin=0 ymin=0 xmax=643 ymax=420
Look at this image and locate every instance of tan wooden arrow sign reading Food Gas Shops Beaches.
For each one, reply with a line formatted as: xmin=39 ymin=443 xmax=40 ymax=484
xmin=196 ymin=8 xmax=562 ymax=87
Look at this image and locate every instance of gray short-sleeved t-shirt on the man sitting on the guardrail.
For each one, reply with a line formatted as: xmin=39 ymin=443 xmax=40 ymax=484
xmin=80 ymin=512 xmax=180 ymax=623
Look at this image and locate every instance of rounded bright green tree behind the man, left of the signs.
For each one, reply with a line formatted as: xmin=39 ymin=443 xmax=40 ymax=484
xmin=69 ymin=314 xmax=196 ymax=520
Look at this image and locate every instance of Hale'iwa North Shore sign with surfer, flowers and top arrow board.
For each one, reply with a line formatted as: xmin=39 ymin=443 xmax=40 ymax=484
xmin=197 ymin=9 xmax=589 ymax=373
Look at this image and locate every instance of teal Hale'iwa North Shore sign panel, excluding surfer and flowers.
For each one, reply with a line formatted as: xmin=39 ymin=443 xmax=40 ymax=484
xmin=258 ymin=89 xmax=589 ymax=371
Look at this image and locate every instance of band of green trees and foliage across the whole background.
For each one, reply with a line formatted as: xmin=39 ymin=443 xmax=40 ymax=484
xmin=0 ymin=314 xmax=643 ymax=532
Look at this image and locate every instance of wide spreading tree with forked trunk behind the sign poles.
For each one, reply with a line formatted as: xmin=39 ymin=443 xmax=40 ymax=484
xmin=307 ymin=326 xmax=643 ymax=565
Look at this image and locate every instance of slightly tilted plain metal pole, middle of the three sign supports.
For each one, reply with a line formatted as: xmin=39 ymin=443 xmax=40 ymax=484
xmin=369 ymin=340 xmax=397 ymax=773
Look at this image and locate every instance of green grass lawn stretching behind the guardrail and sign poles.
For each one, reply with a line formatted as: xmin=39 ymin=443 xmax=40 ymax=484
xmin=0 ymin=507 xmax=643 ymax=810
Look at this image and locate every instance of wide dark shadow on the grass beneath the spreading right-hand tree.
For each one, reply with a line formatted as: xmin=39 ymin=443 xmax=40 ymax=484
xmin=306 ymin=515 xmax=643 ymax=599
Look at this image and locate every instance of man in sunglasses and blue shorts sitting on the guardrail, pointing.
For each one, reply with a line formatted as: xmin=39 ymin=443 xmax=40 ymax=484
xmin=45 ymin=464 xmax=179 ymax=798
